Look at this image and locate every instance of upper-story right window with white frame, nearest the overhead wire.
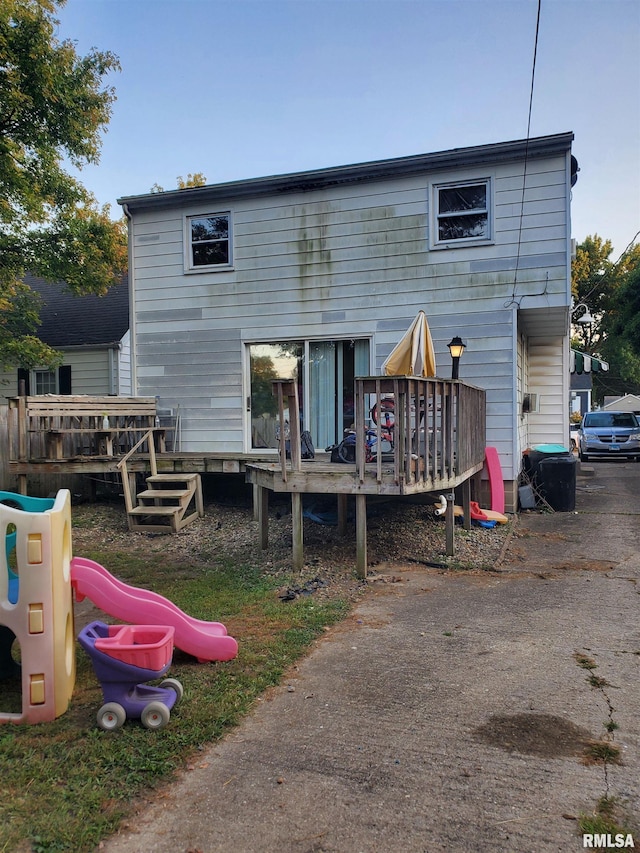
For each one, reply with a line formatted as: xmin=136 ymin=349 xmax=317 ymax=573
xmin=433 ymin=179 xmax=492 ymax=246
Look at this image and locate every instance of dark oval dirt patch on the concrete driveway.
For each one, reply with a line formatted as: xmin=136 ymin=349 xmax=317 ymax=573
xmin=474 ymin=714 xmax=594 ymax=758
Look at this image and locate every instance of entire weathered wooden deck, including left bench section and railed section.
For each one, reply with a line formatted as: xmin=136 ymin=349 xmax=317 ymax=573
xmin=8 ymin=376 xmax=485 ymax=577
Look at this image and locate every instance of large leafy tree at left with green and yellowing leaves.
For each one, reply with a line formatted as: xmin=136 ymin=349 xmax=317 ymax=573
xmin=0 ymin=0 xmax=127 ymax=368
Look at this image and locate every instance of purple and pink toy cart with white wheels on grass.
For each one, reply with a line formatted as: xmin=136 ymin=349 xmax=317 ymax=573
xmin=78 ymin=622 xmax=183 ymax=731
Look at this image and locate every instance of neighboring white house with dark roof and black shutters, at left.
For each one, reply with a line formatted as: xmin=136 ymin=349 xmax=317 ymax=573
xmin=0 ymin=274 xmax=131 ymax=402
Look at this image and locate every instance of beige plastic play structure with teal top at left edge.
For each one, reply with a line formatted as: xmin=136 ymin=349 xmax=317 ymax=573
xmin=0 ymin=489 xmax=75 ymax=723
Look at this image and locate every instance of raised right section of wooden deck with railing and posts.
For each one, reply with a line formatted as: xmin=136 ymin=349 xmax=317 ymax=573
xmin=247 ymin=376 xmax=485 ymax=577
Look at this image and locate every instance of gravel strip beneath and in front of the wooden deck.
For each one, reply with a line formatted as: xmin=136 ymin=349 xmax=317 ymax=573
xmin=73 ymin=492 xmax=515 ymax=597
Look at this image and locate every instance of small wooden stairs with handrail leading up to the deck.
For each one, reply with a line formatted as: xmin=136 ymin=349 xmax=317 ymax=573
xmin=118 ymin=432 xmax=204 ymax=533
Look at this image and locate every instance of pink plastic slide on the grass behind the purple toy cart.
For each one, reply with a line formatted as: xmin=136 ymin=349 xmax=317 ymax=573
xmin=71 ymin=557 xmax=238 ymax=663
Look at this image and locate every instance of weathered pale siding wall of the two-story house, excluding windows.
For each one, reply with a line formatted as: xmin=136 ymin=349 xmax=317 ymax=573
xmin=125 ymin=138 xmax=570 ymax=486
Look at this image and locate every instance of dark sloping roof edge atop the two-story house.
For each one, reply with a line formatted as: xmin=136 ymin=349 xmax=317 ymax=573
xmin=118 ymin=133 xmax=578 ymax=211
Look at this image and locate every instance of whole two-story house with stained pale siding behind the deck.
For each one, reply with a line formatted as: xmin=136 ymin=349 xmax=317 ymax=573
xmin=120 ymin=133 xmax=577 ymax=506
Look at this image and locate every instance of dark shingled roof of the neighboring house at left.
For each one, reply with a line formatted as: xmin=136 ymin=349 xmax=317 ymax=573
xmin=24 ymin=273 xmax=129 ymax=349
